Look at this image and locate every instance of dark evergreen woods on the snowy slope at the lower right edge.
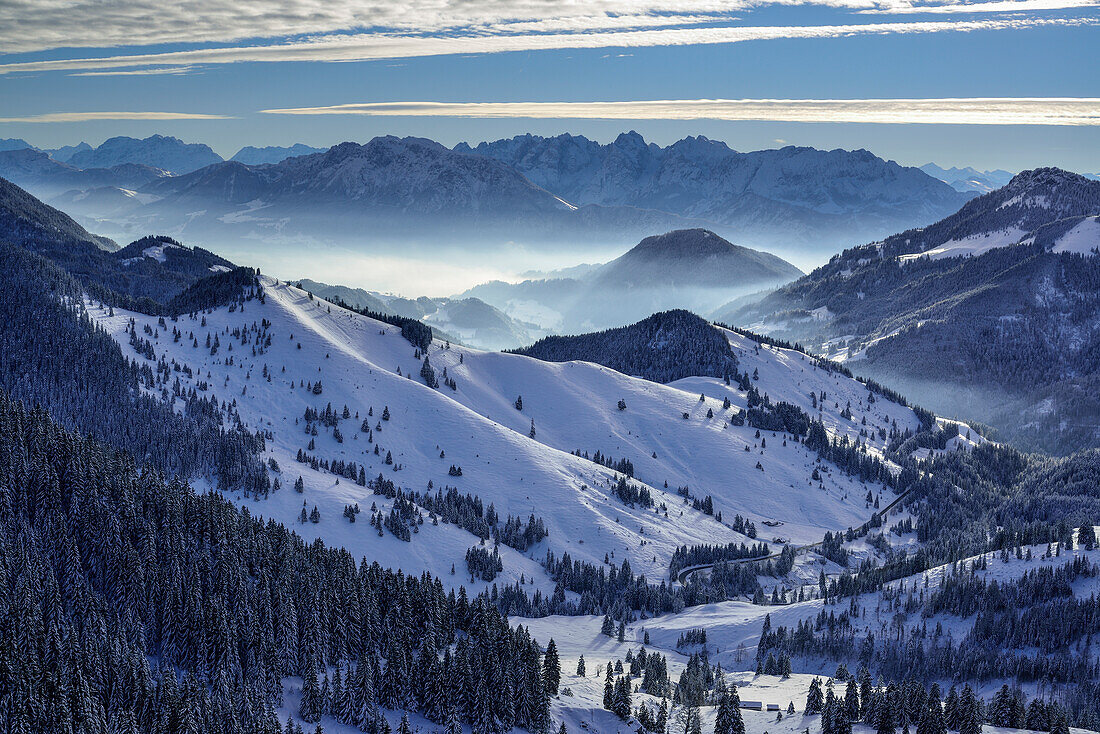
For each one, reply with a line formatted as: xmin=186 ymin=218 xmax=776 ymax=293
xmin=757 ymin=557 xmax=1100 ymax=728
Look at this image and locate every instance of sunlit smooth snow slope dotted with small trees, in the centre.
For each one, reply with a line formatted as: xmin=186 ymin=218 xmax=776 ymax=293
xmin=88 ymin=277 xmax=916 ymax=593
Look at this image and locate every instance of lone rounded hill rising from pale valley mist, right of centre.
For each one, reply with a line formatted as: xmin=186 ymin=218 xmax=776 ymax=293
xmin=463 ymin=229 xmax=802 ymax=333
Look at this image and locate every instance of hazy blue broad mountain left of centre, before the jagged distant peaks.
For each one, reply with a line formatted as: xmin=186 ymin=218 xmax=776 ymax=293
xmin=133 ymin=136 xmax=708 ymax=250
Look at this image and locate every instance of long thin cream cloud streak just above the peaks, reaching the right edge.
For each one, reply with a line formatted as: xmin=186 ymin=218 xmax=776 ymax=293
xmin=255 ymin=97 xmax=1100 ymax=125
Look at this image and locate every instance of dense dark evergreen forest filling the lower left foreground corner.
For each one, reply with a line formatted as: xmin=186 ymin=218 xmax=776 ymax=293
xmin=0 ymin=394 xmax=549 ymax=734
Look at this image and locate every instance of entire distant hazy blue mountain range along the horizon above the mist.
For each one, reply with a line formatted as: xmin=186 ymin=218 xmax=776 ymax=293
xmin=0 ymin=133 xmax=972 ymax=262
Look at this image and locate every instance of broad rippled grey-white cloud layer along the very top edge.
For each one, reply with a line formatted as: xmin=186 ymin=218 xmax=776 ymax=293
xmin=0 ymin=0 xmax=1098 ymax=53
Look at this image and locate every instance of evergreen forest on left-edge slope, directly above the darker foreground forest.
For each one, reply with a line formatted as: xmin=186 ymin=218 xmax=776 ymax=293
xmin=0 ymin=244 xmax=270 ymax=493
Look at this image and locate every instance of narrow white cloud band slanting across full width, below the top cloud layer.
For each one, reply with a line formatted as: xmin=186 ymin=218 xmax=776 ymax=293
xmin=0 ymin=17 xmax=1100 ymax=75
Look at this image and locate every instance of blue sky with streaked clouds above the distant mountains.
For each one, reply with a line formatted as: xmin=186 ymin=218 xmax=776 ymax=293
xmin=0 ymin=0 xmax=1100 ymax=173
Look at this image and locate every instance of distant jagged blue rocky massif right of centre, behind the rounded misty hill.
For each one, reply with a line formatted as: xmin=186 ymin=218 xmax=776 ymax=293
xmin=455 ymin=132 xmax=968 ymax=259
